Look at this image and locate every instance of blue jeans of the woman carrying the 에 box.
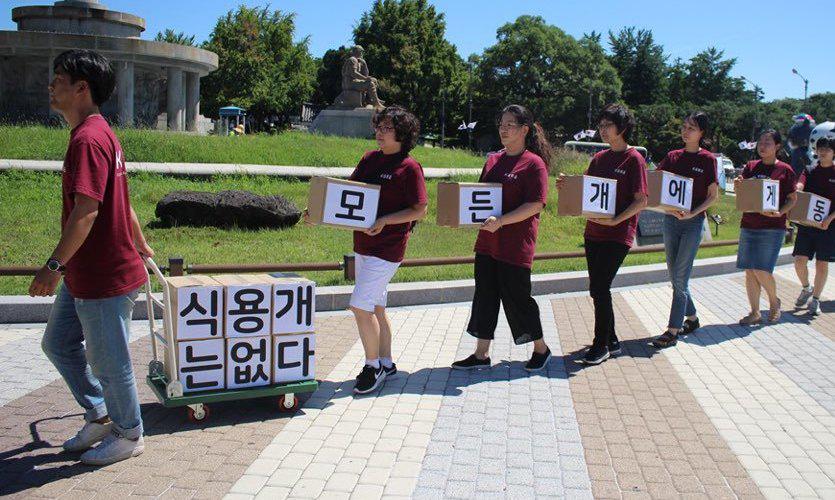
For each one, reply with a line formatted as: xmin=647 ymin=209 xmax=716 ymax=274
xmin=664 ymin=213 xmax=705 ymax=329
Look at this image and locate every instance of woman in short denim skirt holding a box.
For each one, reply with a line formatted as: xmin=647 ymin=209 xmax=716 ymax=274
xmin=734 ymin=129 xmax=797 ymax=326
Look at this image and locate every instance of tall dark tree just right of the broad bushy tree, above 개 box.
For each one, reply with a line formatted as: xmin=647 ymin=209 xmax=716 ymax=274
xmin=609 ymin=26 xmax=667 ymax=106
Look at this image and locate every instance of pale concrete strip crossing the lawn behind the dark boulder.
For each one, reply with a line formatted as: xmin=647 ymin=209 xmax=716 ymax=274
xmin=0 ymin=159 xmax=481 ymax=179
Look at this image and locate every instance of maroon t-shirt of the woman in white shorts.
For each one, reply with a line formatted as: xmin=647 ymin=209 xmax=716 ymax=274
xmin=350 ymin=150 xmax=429 ymax=262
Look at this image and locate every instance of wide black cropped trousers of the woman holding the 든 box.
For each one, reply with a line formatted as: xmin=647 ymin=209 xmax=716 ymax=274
xmin=467 ymin=254 xmax=542 ymax=345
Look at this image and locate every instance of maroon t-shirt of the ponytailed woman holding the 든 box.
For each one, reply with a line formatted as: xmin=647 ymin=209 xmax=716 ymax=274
xmin=474 ymin=150 xmax=548 ymax=269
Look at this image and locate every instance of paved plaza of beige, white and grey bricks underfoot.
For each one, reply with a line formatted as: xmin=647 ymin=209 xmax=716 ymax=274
xmin=0 ymin=267 xmax=835 ymax=500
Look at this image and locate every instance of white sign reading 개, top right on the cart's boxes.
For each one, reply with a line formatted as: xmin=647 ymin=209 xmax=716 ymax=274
xmin=272 ymin=280 xmax=316 ymax=334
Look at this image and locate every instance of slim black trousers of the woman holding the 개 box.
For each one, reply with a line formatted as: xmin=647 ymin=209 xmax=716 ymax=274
xmin=585 ymin=239 xmax=629 ymax=347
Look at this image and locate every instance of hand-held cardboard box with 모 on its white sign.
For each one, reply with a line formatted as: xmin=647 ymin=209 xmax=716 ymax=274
xmin=307 ymin=177 xmax=380 ymax=230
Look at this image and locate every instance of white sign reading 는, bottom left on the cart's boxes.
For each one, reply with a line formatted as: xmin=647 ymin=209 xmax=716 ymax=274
xmin=177 ymin=339 xmax=225 ymax=393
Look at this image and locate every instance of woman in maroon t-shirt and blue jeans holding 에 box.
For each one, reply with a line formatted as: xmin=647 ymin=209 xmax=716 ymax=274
xmin=652 ymin=111 xmax=719 ymax=348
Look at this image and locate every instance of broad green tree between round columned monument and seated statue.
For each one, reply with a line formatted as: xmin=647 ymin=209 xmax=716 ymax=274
xmin=201 ymin=6 xmax=316 ymax=128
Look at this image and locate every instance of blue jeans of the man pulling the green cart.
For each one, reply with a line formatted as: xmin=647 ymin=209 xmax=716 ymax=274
xmin=41 ymin=285 xmax=142 ymax=439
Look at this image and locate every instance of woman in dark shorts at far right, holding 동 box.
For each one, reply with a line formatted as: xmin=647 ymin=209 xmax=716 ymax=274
xmin=792 ymin=137 xmax=835 ymax=316
